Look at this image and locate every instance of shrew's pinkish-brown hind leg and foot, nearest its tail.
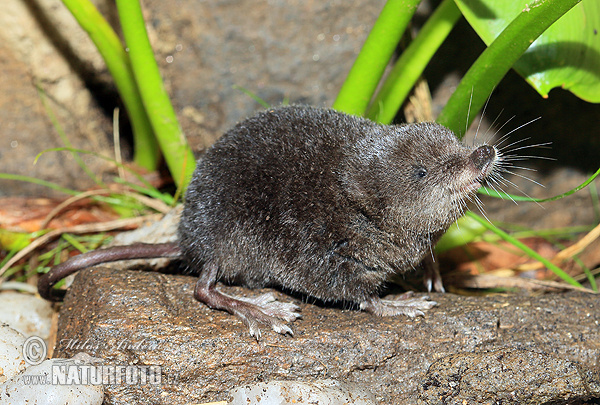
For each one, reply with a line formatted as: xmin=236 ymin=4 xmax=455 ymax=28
xmin=194 ymin=264 xmax=301 ymax=340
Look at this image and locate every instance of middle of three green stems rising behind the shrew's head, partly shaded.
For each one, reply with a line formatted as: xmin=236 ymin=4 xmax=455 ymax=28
xmin=367 ymin=0 xmax=462 ymax=124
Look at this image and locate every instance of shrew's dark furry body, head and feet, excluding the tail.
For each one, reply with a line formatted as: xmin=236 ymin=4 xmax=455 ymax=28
xmin=38 ymin=107 xmax=497 ymax=337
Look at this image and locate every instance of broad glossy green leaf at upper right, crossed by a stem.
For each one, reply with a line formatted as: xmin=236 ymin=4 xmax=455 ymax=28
xmin=455 ymin=0 xmax=600 ymax=103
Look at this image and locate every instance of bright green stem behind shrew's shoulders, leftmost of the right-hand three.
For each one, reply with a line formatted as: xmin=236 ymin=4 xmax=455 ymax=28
xmin=333 ymin=0 xmax=420 ymax=115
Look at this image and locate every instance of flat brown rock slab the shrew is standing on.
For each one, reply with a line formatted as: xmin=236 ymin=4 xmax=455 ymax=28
xmin=54 ymin=268 xmax=600 ymax=404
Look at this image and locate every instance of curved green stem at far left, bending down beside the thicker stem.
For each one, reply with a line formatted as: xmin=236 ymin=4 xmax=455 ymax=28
xmin=62 ymin=0 xmax=160 ymax=170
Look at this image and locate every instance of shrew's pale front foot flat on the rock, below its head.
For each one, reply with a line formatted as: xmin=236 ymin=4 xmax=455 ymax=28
xmin=360 ymin=292 xmax=437 ymax=318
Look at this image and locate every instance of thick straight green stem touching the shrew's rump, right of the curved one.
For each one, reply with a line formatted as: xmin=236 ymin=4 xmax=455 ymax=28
xmin=117 ymin=0 xmax=195 ymax=187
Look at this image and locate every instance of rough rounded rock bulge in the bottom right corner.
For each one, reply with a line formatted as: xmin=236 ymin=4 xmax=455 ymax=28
xmin=421 ymin=349 xmax=600 ymax=405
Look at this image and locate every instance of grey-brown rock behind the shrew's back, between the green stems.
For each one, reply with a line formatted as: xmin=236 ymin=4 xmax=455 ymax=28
xmin=144 ymin=0 xmax=385 ymax=149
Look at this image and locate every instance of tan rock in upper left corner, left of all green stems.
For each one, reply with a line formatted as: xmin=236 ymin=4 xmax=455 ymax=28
xmin=0 ymin=0 xmax=115 ymax=195
